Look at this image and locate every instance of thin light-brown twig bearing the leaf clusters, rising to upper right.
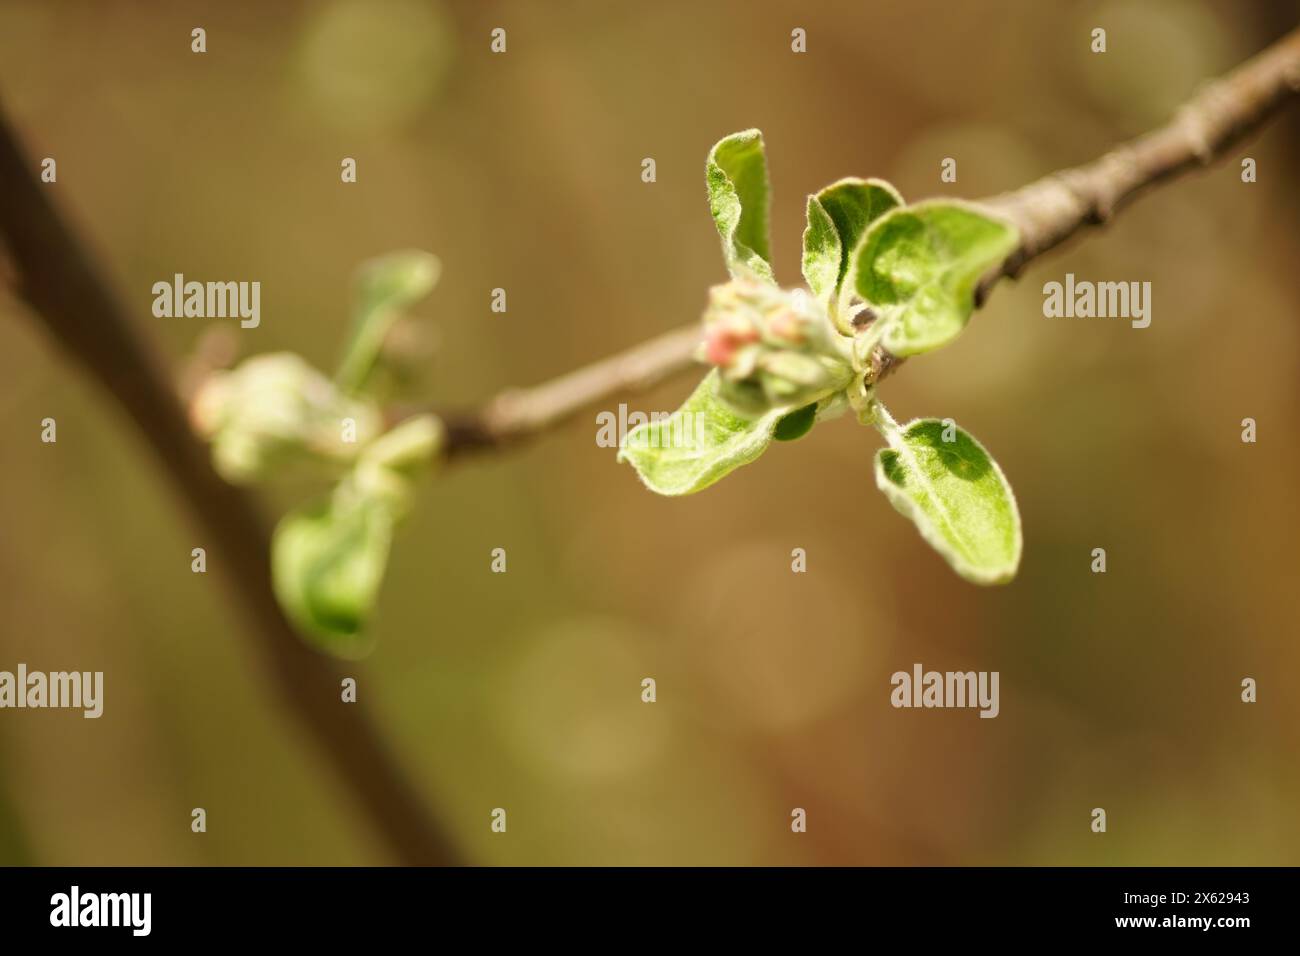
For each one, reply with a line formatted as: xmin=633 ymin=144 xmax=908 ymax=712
xmin=443 ymin=29 xmax=1300 ymax=459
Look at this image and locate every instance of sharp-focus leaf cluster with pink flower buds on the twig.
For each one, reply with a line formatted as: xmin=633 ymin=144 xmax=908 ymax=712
xmin=619 ymin=130 xmax=1022 ymax=584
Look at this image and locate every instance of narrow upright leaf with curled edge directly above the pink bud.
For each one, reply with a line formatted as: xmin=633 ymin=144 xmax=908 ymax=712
xmin=705 ymin=130 xmax=775 ymax=281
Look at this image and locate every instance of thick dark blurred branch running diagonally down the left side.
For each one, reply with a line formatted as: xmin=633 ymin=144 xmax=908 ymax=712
xmin=0 ymin=113 xmax=460 ymax=864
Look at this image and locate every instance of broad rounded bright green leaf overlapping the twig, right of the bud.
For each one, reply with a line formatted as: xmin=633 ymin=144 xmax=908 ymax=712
xmin=853 ymin=200 xmax=1018 ymax=355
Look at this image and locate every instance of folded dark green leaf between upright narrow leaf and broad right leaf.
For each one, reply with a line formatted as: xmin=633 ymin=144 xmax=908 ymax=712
xmin=803 ymin=178 xmax=902 ymax=304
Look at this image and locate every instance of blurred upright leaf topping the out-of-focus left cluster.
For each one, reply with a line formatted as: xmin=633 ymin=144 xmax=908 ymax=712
xmin=335 ymin=250 xmax=442 ymax=394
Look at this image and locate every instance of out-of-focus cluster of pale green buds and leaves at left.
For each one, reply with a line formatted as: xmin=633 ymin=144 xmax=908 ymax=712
xmin=191 ymin=251 xmax=443 ymax=657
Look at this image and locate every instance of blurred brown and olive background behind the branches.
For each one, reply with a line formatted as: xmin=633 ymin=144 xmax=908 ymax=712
xmin=0 ymin=0 xmax=1300 ymax=865
